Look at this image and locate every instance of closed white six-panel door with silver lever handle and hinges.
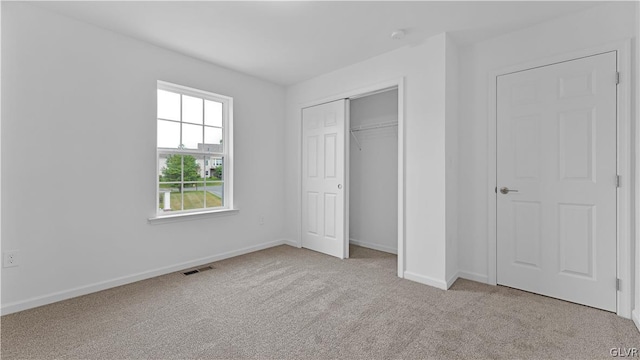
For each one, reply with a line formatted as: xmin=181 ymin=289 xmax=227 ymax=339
xmin=497 ymin=52 xmax=617 ymax=311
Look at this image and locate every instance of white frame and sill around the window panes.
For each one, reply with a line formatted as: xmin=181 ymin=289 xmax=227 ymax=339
xmin=149 ymin=80 xmax=237 ymax=221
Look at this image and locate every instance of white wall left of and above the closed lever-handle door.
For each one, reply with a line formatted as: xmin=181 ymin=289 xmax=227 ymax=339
xmin=458 ymin=2 xmax=637 ymax=306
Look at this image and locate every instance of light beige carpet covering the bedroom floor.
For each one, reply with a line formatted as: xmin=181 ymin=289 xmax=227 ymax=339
xmin=1 ymin=246 xmax=640 ymax=359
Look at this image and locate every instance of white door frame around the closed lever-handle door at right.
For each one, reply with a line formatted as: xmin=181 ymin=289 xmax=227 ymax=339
xmin=487 ymin=39 xmax=637 ymax=318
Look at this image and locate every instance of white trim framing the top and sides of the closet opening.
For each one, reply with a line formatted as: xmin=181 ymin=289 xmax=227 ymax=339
xmin=297 ymin=77 xmax=405 ymax=278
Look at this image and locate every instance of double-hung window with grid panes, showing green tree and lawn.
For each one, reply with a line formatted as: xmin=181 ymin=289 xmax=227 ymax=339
xmin=156 ymin=81 xmax=233 ymax=216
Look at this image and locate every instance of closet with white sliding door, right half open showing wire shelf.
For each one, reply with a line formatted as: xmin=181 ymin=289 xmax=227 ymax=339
xmin=299 ymin=78 xmax=405 ymax=278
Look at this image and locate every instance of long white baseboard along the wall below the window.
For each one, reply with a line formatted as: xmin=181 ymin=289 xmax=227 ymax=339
xmin=0 ymin=239 xmax=290 ymax=315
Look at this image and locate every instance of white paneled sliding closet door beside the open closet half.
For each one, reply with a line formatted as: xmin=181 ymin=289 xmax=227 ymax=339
xmin=302 ymin=100 xmax=348 ymax=259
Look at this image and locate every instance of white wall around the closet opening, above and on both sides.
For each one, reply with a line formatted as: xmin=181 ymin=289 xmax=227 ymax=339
xmin=284 ymin=34 xmax=446 ymax=288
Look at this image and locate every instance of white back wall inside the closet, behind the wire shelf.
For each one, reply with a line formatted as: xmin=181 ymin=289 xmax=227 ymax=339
xmin=347 ymin=90 xmax=398 ymax=254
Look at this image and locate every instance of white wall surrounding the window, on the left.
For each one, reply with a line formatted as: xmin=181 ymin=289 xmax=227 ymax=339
xmin=1 ymin=2 xmax=285 ymax=313
